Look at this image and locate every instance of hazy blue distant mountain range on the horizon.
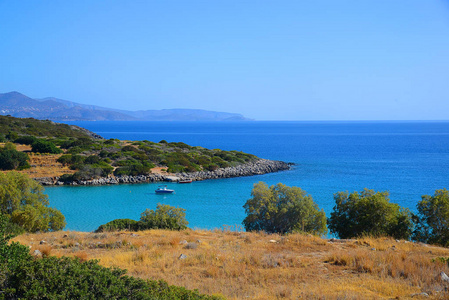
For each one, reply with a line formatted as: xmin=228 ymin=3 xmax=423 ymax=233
xmin=0 ymin=92 xmax=249 ymax=121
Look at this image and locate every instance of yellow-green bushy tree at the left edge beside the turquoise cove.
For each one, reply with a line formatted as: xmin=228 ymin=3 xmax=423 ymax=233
xmin=0 ymin=171 xmax=65 ymax=232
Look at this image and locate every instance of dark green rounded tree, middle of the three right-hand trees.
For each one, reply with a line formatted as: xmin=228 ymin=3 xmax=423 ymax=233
xmin=328 ymin=189 xmax=413 ymax=239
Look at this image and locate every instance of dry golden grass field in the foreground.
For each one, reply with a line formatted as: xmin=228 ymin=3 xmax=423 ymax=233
xmin=14 ymin=229 xmax=449 ymax=299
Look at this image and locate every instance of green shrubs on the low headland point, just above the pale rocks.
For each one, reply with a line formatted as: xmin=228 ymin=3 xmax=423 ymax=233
xmin=58 ymin=139 xmax=257 ymax=180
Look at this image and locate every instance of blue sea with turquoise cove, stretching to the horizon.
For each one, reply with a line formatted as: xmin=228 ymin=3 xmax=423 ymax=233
xmin=46 ymin=121 xmax=449 ymax=231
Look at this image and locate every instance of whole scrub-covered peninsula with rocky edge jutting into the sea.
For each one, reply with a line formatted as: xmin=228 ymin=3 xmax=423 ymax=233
xmin=0 ymin=116 xmax=290 ymax=185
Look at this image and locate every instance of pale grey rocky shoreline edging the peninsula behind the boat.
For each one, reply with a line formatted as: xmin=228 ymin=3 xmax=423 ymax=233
xmin=35 ymin=159 xmax=292 ymax=185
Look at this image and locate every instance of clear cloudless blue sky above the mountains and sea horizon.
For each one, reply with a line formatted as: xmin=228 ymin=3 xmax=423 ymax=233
xmin=0 ymin=0 xmax=449 ymax=120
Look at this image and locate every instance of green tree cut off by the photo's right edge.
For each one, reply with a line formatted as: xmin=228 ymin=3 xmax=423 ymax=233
xmin=413 ymin=189 xmax=449 ymax=246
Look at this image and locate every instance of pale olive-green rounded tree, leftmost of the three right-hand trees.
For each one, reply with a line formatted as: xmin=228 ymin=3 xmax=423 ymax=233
xmin=243 ymin=182 xmax=327 ymax=235
